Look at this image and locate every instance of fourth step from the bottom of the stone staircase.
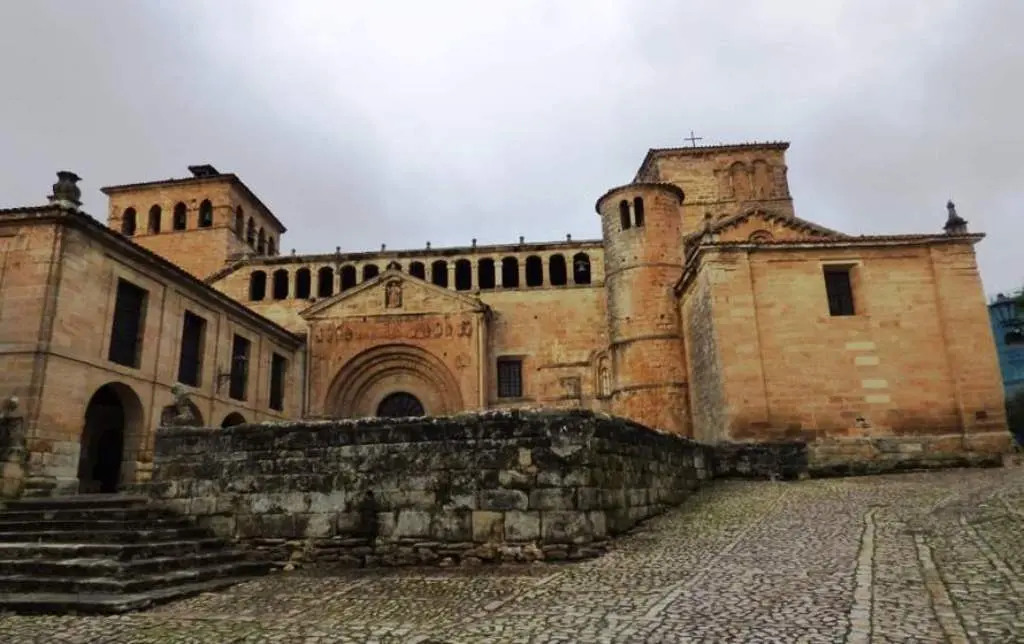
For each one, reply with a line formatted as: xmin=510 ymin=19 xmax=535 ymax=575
xmin=0 ymin=536 xmax=227 ymax=561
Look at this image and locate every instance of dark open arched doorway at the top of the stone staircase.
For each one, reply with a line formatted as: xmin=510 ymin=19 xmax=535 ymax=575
xmin=78 ymin=383 xmax=142 ymax=493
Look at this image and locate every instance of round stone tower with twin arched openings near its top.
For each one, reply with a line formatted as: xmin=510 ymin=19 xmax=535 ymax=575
xmin=597 ymin=183 xmax=689 ymax=435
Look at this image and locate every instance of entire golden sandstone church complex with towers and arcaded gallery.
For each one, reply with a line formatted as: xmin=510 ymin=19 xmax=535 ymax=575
xmin=0 ymin=142 xmax=1009 ymax=493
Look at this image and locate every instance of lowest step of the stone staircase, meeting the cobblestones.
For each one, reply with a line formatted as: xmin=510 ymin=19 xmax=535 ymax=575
xmin=0 ymin=575 xmax=268 ymax=614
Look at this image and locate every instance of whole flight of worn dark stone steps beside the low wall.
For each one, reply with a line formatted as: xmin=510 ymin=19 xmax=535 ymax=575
xmin=0 ymin=495 xmax=270 ymax=613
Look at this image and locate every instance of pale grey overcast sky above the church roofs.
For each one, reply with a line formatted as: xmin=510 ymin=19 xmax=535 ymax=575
xmin=0 ymin=0 xmax=1024 ymax=294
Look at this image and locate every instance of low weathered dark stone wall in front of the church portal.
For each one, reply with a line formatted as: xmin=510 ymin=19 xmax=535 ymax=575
xmin=147 ymin=411 xmax=712 ymax=565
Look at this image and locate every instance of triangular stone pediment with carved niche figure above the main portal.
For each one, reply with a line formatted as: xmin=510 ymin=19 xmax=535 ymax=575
xmin=299 ymin=268 xmax=486 ymax=319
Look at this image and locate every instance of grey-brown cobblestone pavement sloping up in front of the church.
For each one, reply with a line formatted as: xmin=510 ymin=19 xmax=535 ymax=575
xmin=0 ymin=467 xmax=1024 ymax=644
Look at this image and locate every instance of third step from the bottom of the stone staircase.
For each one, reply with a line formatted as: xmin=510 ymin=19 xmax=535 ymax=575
xmin=0 ymin=549 xmax=246 ymax=579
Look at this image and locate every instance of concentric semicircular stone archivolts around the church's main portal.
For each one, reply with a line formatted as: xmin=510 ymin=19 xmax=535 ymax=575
xmin=324 ymin=344 xmax=463 ymax=418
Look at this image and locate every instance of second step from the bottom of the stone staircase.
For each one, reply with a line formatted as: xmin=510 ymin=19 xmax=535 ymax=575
xmin=0 ymin=561 xmax=270 ymax=594
